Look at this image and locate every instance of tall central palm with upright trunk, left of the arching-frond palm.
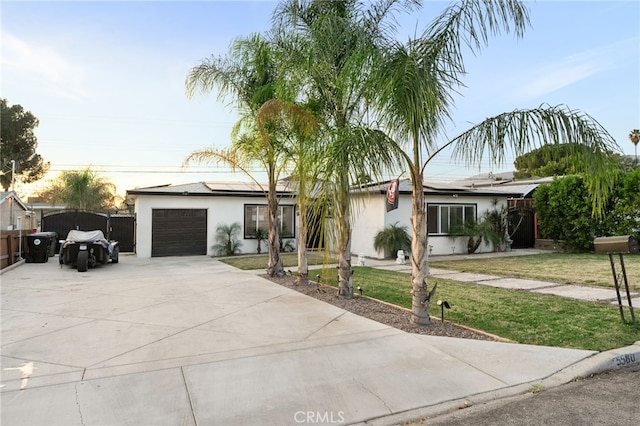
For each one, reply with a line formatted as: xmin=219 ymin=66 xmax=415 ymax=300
xmin=274 ymin=0 xmax=408 ymax=298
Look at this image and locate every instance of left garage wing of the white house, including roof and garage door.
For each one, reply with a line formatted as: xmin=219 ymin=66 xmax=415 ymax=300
xmin=127 ymin=182 xmax=297 ymax=257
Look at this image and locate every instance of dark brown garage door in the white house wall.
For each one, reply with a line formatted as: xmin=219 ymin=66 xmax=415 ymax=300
xmin=151 ymin=209 xmax=207 ymax=257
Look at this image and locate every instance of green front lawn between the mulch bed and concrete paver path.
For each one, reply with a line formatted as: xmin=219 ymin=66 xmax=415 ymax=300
xmin=322 ymin=267 xmax=640 ymax=351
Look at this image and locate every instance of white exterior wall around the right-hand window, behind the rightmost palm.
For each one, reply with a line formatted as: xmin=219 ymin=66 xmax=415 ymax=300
xmin=351 ymin=194 xmax=507 ymax=259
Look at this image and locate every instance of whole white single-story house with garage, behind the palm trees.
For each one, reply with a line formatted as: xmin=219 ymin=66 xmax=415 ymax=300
xmin=127 ymin=180 xmax=513 ymax=258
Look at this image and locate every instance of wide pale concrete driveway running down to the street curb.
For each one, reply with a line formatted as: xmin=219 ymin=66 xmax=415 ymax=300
xmin=0 ymin=256 xmax=640 ymax=425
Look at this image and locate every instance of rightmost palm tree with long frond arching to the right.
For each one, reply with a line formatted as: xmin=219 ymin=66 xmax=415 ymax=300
xmin=375 ymin=0 xmax=616 ymax=324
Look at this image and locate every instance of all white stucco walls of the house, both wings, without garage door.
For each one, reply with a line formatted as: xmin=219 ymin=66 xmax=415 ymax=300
xmin=131 ymin=180 xmax=510 ymax=258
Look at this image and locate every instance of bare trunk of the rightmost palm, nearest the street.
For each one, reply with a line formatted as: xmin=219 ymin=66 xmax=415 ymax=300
xmin=411 ymin=178 xmax=431 ymax=324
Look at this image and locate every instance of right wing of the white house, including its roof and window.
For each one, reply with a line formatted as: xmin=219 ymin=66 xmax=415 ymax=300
xmin=351 ymin=179 xmax=517 ymax=258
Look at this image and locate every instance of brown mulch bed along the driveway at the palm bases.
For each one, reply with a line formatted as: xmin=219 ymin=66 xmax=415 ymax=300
xmin=261 ymin=274 xmax=505 ymax=341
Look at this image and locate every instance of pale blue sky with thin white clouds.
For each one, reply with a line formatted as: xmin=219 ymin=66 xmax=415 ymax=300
xmin=0 ymin=0 xmax=640 ymax=196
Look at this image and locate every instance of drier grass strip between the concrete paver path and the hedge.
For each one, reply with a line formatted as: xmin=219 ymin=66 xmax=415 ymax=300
xmin=429 ymin=253 xmax=640 ymax=291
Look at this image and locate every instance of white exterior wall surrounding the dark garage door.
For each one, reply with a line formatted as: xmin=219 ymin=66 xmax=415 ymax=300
xmin=135 ymin=195 xmax=296 ymax=257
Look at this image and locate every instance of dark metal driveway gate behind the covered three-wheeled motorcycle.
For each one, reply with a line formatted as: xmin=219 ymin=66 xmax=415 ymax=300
xmin=41 ymin=210 xmax=135 ymax=252
